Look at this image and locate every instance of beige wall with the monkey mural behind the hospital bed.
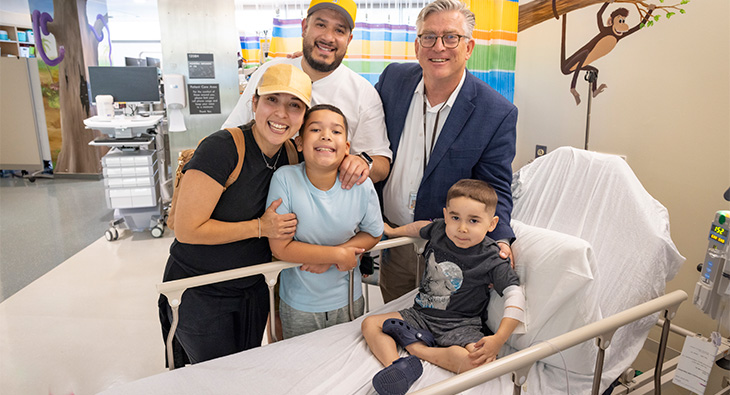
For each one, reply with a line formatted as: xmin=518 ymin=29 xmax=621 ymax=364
xmin=513 ymin=1 xmax=730 ymax=392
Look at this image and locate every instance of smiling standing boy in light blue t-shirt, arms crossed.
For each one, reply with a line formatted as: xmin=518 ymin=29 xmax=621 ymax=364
xmin=267 ymin=105 xmax=383 ymax=338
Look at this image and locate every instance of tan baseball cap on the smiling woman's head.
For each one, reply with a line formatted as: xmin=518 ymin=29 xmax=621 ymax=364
xmin=256 ymin=63 xmax=312 ymax=107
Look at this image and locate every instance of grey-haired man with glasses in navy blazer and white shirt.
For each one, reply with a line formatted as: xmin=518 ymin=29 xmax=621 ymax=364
xmin=375 ymin=0 xmax=517 ymax=302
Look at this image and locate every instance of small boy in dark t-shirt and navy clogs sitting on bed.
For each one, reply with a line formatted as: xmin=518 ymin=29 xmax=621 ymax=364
xmin=362 ymin=179 xmax=525 ymax=395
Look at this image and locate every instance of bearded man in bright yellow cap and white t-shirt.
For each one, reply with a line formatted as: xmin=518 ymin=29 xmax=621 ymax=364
xmin=223 ymin=0 xmax=392 ymax=189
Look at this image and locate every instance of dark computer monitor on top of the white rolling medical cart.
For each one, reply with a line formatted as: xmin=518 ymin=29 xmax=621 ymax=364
xmin=89 ymin=66 xmax=160 ymax=103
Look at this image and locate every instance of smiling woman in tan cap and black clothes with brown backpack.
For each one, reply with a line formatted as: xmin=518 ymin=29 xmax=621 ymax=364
xmin=159 ymin=64 xmax=312 ymax=366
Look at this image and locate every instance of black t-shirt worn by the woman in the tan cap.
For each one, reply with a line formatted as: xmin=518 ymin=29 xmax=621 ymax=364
xmin=165 ymin=123 xmax=289 ymax=287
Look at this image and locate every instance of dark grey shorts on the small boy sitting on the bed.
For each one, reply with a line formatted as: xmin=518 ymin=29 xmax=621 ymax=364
xmin=399 ymin=308 xmax=484 ymax=347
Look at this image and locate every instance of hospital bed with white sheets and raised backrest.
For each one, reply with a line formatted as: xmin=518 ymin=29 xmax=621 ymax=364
xmin=105 ymin=148 xmax=687 ymax=394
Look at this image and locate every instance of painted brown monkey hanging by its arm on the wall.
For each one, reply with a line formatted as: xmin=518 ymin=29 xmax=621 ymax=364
xmin=552 ymin=0 xmax=656 ymax=105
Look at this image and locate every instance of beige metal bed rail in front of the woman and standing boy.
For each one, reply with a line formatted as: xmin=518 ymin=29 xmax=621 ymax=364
xmin=157 ymin=237 xmax=426 ymax=370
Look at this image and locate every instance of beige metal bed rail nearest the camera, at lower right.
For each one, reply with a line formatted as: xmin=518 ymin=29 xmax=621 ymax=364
xmin=414 ymin=290 xmax=687 ymax=395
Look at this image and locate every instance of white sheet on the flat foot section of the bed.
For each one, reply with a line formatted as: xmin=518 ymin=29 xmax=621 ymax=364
xmin=102 ymin=291 xmax=512 ymax=395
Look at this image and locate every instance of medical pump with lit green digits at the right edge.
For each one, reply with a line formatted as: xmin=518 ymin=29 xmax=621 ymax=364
xmin=693 ymin=210 xmax=730 ymax=327
